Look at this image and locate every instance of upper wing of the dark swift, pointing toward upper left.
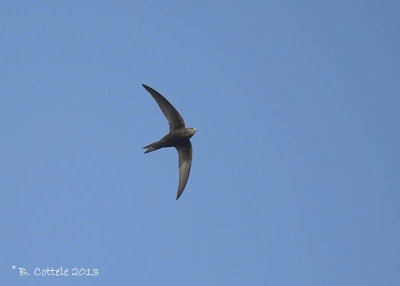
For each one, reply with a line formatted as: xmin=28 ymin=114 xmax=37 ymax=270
xmin=142 ymin=84 xmax=185 ymax=132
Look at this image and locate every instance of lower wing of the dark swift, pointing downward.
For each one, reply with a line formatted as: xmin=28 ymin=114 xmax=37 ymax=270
xmin=175 ymin=140 xmax=193 ymax=199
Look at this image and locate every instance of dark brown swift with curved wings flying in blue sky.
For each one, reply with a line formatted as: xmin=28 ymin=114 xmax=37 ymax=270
xmin=142 ymin=84 xmax=197 ymax=200
